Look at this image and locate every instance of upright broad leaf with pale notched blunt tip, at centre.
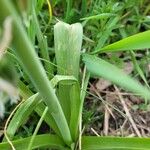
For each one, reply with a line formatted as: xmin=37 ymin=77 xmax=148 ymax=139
xmin=54 ymin=22 xmax=83 ymax=139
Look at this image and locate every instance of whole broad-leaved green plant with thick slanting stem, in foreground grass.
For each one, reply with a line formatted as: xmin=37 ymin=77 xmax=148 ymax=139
xmin=0 ymin=0 xmax=150 ymax=150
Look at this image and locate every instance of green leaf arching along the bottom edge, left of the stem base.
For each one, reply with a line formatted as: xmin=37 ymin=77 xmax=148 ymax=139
xmin=0 ymin=134 xmax=68 ymax=150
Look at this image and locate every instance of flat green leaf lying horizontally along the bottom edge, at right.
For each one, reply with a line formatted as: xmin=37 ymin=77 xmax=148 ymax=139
xmin=82 ymin=136 xmax=150 ymax=150
